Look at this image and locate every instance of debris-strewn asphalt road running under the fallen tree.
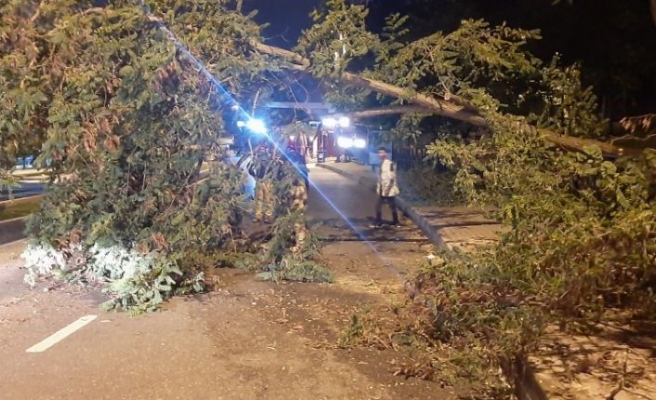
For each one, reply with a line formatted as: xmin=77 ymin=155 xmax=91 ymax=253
xmin=0 ymin=168 xmax=434 ymax=400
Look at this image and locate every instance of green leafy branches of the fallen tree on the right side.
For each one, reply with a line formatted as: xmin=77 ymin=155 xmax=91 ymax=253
xmin=278 ymin=0 xmax=656 ymax=394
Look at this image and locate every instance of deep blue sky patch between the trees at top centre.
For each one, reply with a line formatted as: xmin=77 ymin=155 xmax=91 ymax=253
xmin=244 ymin=0 xmax=321 ymax=48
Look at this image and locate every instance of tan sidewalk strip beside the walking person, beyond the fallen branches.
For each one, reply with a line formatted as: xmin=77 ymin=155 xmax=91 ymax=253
xmin=317 ymin=163 xmax=503 ymax=250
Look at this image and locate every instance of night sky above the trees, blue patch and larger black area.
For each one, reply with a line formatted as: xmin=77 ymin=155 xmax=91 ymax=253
xmin=244 ymin=0 xmax=656 ymax=115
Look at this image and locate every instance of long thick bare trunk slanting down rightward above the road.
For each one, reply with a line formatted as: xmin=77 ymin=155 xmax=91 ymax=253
xmin=251 ymin=40 xmax=636 ymax=157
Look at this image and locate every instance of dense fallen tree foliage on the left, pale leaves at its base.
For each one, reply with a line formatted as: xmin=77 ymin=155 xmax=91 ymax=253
xmin=0 ymin=0 xmax=324 ymax=310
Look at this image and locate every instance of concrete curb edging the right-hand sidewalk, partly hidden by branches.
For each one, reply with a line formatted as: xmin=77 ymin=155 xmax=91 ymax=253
xmin=318 ymin=164 xmax=548 ymax=400
